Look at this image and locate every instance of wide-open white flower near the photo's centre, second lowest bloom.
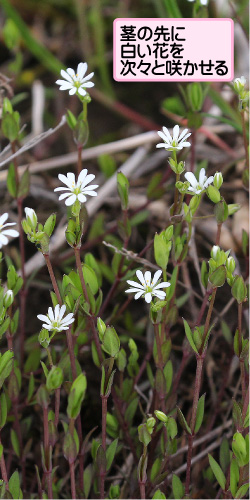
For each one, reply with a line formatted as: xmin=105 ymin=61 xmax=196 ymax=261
xmin=126 ymin=270 xmax=170 ymax=304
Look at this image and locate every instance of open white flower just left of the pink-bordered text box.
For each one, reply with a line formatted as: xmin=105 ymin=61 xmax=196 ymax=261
xmin=56 ymin=63 xmax=95 ymax=96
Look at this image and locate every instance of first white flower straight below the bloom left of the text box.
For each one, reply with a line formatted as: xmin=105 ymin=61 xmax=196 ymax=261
xmin=54 ymin=168 xmax=98 ymax=206
